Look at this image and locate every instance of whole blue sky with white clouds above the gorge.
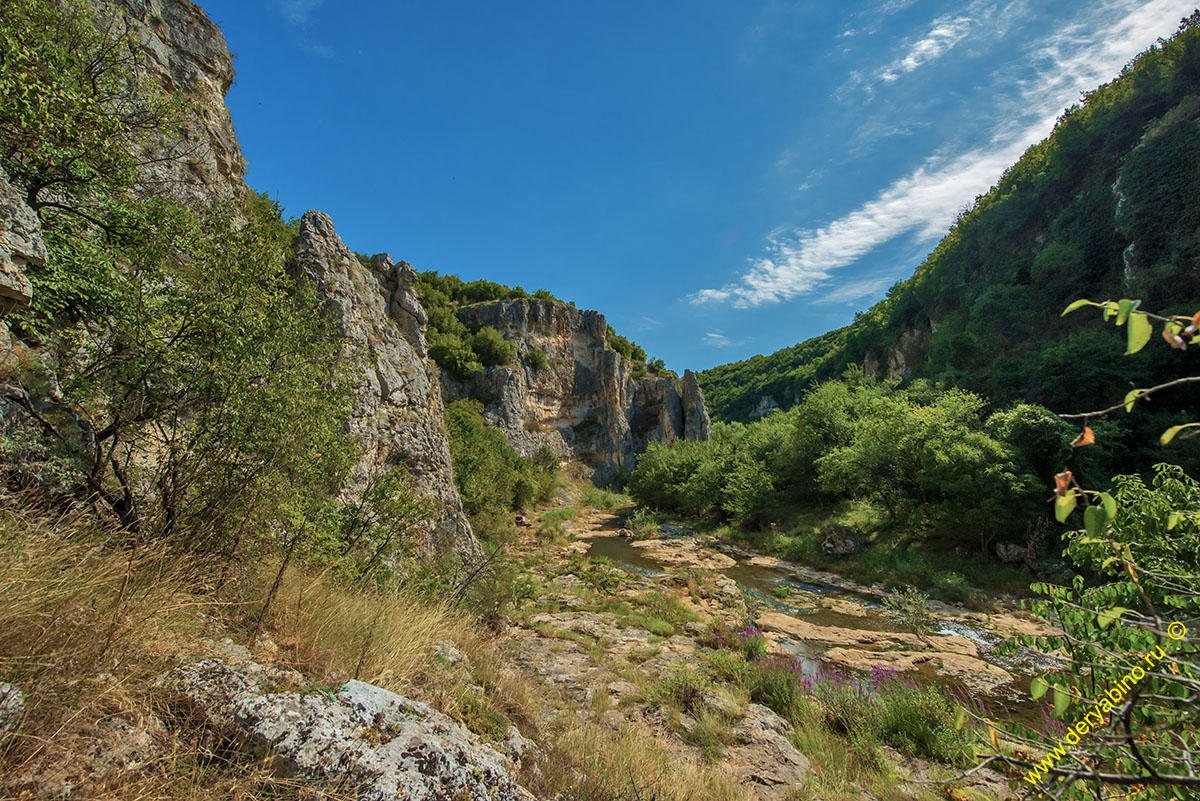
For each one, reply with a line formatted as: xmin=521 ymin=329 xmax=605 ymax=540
xmin=200 ymin=0 xmax=1195 ymax=371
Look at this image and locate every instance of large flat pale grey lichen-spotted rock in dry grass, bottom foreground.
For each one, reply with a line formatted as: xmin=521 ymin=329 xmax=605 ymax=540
xmin=163 ymin=660 xmax=534 ymax=801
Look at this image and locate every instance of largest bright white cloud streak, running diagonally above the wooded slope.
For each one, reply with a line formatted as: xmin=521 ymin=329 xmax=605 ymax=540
xmin=689 ymin=0 xmax=1192 ymax=308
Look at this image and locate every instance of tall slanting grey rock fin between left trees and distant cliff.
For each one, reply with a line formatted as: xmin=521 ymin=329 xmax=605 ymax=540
xmin=289 ymin=211 xmax=479 ymax=558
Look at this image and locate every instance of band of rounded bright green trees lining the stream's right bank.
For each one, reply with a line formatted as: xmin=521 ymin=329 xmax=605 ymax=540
xmin=628 ymin=371 xmax=1051 ymax=542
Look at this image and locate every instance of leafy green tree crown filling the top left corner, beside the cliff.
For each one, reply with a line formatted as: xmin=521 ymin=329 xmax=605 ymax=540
xmin=0 ymin=0 xmax=181 ymax=224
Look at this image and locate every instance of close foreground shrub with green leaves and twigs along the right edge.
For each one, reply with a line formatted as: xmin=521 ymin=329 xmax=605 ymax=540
xmin=969 ymin=299 xmax=1200 ymax=800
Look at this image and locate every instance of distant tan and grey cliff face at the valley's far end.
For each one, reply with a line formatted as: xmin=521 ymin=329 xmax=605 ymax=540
xmin=443 ymin=301 xmax=709 ymax=482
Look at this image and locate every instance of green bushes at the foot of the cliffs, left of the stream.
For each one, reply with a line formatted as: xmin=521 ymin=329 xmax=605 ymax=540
xmin=445 ymin=401 xmax=558 ymax=535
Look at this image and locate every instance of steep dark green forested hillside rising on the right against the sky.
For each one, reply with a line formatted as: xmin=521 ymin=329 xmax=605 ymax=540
xmin=700 ymin=12 xmax=1200 ymax=420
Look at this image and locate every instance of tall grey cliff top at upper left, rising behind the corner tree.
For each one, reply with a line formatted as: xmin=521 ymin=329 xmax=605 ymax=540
xmin=102 ymin=0 xmax=246 ymax=207
